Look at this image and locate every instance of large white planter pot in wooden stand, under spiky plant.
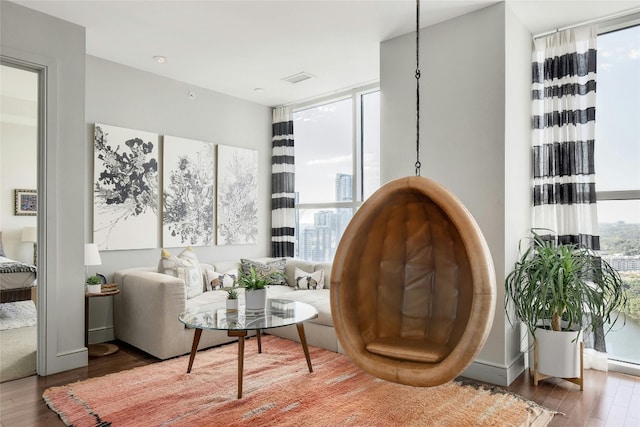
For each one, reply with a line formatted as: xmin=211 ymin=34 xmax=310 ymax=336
xmin=536 ymin=328 xmax=582 ymax=378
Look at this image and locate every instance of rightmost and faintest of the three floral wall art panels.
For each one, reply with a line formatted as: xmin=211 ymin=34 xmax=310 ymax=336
xmin=217 ymin=145 xmax=258 ymax=245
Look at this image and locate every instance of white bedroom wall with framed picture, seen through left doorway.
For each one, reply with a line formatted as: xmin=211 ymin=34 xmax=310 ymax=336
xmin=0 ymin=119 xmax=38 ymax=264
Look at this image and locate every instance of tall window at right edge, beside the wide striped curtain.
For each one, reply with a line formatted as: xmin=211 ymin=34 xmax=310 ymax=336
xmin=595 ymin=21 xmax=640 ymax=365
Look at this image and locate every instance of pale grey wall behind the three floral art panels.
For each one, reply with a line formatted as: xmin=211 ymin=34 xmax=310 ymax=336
xmin=84 ymin=56 xmax=271 ymax=343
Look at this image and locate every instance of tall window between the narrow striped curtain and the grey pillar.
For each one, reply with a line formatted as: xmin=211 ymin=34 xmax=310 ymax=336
xmin=293 ymin=88 xmax=380 ymax=261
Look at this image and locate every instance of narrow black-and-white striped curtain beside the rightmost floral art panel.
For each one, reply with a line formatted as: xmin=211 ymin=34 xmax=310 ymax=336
xmin=271 ymin=107 xmax=296 ymax=257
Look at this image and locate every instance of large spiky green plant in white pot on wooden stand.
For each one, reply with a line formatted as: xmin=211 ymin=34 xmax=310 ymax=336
xmin=505 ymin=229 xmax=627 ymax=387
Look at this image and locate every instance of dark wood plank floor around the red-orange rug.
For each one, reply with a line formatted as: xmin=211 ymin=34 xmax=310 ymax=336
xmin=0 ymin=342 xmax=640 ymax=427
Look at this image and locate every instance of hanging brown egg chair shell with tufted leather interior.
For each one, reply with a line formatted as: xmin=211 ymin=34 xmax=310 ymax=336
xmin=331 ymin=177 xmax=496 ymax=387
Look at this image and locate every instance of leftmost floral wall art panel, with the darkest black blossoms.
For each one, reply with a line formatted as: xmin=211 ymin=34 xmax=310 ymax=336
xmin=93 ymin=123 xmax=159 ymax=250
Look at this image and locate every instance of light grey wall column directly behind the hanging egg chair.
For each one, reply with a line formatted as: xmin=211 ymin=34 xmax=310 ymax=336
xmin=380 ymin=3 xmax=530 ymax=384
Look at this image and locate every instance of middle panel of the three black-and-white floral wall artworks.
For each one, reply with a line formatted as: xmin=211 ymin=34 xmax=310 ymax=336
xmin=162 ymin=136 xmax=215 ymax=247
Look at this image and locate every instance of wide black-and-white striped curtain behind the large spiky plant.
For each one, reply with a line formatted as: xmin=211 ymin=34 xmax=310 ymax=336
xmin=532 ymin=27 xmax=600 ymax=250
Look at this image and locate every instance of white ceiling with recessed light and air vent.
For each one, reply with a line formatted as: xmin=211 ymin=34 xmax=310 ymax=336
xmin=7 ymin=0 xmax=640 ymax=106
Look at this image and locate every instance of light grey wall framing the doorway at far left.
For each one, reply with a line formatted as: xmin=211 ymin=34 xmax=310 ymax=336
xmin=0 ymin=1 xmax=87 ymax=375
